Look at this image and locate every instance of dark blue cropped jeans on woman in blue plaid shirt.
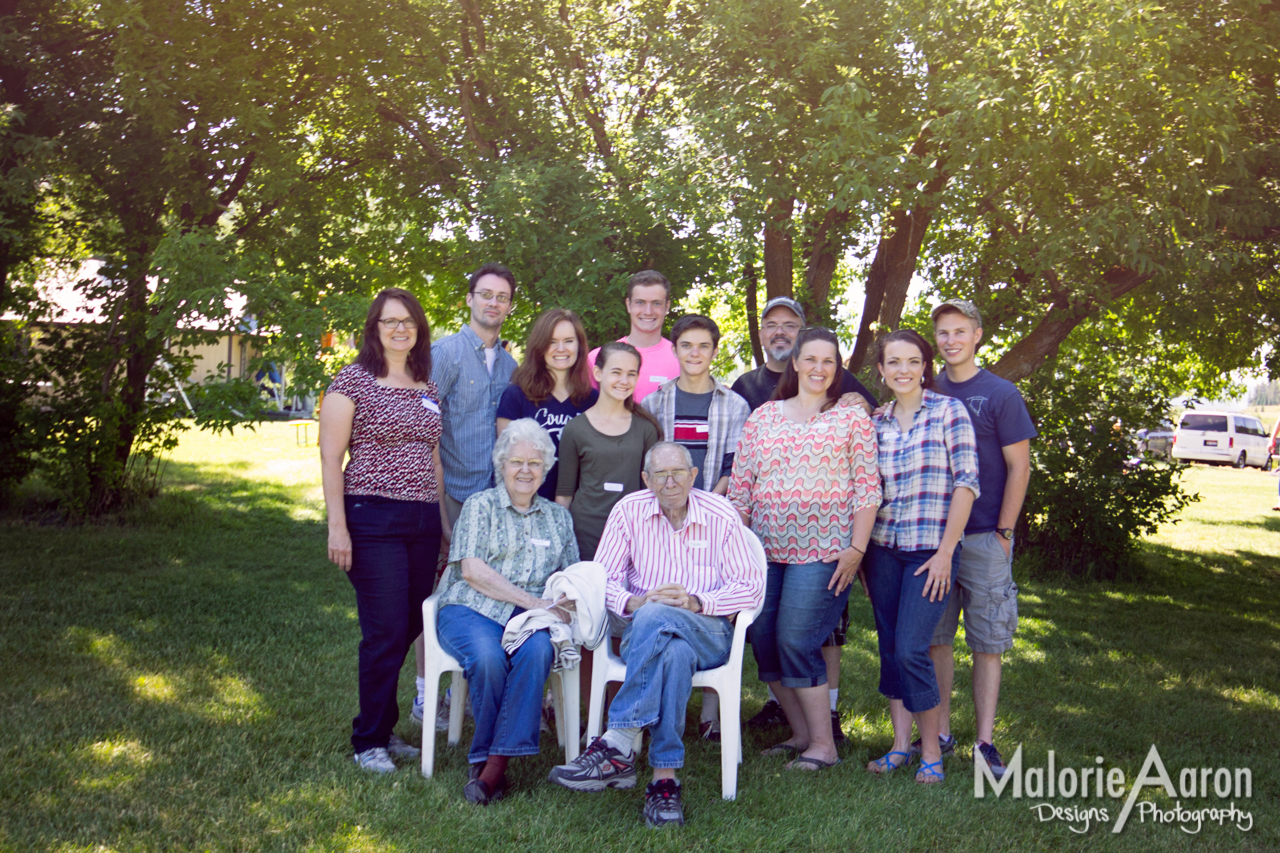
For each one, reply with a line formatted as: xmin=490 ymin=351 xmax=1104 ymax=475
xmin=864 ymin=543 xmax=964 ymax=713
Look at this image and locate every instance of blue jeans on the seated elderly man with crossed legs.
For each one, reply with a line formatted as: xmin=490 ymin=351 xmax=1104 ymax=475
xmin=609 ymin=603 xmax=733 ymax=767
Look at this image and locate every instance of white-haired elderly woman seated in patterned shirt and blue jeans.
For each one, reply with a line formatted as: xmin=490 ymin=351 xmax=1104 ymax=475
xmin=438 ymin=418 xmax=577 ymax=806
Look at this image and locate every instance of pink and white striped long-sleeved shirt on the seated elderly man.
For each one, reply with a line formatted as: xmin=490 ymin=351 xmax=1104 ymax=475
xmin=595 ymin=489 xmax=764 ymax=616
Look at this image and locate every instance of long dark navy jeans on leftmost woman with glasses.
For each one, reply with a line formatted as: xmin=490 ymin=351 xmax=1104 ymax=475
xmin=344 ymin=494 xmax=440 ymax=752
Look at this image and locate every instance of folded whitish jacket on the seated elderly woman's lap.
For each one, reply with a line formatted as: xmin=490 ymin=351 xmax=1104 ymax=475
xmin=502 ymin=561 xmax=609 ymax=672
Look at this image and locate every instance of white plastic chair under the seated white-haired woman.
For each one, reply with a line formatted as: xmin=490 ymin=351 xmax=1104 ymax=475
xmin=422 ymin=593 xmax=580 ymax=779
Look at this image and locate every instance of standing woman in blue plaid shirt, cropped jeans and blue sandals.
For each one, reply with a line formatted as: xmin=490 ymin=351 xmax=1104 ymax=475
xmin=864 ymin=329 xmax=978 ymax=783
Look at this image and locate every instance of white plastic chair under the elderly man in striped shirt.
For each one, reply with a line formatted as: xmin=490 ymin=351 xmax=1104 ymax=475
xmin=586 ymin=530 xmax=768 ymax=799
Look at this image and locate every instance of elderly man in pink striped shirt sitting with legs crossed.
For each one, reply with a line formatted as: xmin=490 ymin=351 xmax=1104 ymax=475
xmin=550 ymin=442 xmax=764 ymax=826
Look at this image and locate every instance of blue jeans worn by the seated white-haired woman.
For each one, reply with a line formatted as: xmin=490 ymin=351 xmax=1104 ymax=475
xmin=437 ymin=605 xmax=556 ymax=765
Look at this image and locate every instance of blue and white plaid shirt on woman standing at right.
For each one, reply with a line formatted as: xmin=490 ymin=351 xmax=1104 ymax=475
xmin=872 ymin=391 xmax=979 ymax=551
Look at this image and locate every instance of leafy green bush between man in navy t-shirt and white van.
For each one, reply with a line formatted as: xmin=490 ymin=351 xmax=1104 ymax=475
xmin=1019 ymin=313 xmax=1203 ymax=579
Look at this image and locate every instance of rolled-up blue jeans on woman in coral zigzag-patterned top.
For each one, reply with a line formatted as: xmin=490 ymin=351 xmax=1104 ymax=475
xmin=749 ymin=562 xmax=849 ymax=688
